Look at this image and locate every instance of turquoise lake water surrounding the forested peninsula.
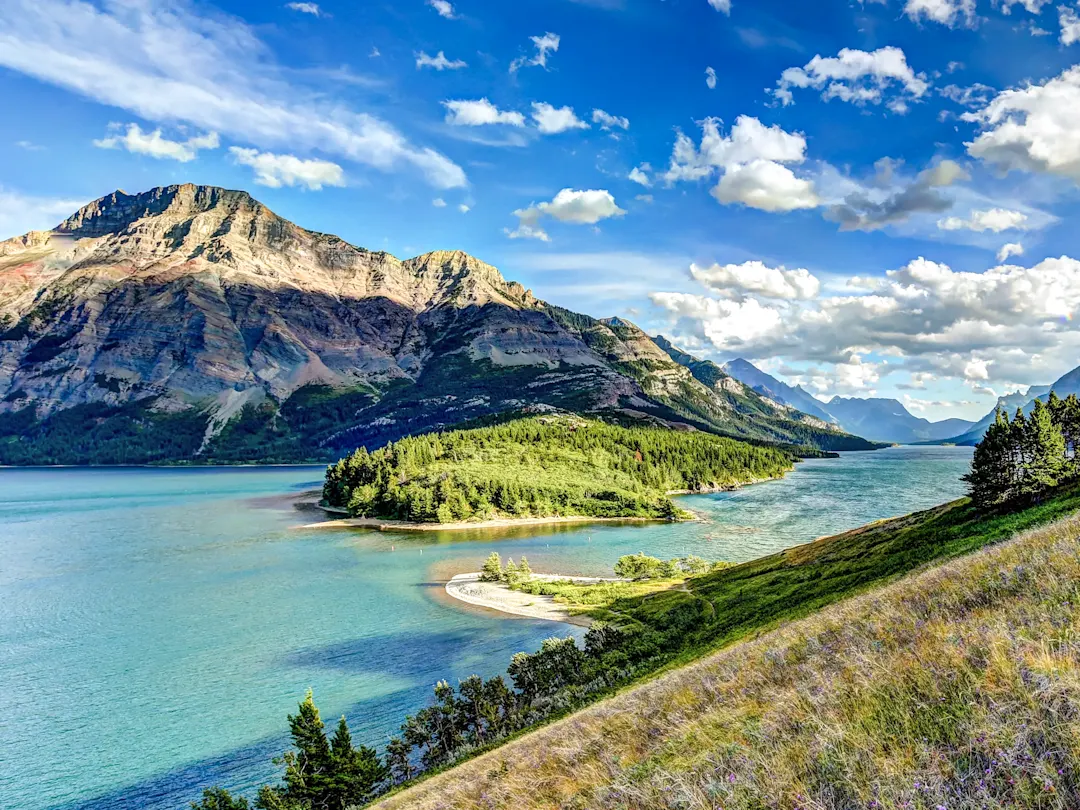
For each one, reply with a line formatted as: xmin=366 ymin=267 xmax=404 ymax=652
xmin=0 ymin=447 xmax=971 ymax=810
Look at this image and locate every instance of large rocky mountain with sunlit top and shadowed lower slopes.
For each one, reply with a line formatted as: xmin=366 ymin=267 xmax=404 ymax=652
xmin=0 ymin=185 xmax=873 ymax=463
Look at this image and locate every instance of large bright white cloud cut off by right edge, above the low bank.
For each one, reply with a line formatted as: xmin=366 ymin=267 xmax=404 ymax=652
xmin=961 ymin=65 xmax=1080 ymax=183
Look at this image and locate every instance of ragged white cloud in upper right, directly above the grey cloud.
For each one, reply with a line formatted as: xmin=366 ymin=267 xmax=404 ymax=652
xmin=772 ymin=45 xmax=930 ymax=112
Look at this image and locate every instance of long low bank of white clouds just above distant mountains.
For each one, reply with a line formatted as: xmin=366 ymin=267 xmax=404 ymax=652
xmin=651 ymin=256 xmax=1080 ymax=384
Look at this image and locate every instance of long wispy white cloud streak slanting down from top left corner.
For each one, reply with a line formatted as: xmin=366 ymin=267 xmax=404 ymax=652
xmin=0 ymin=0 xmax=467 ymax=188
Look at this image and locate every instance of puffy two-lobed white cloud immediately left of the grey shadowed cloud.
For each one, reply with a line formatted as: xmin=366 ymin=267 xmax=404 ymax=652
xmin=663 ymin=116 xmax=821 ymax=212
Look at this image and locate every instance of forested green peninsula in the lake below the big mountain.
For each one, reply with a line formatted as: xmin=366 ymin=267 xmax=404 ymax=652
xmin=323 ymin=416 xmax=793 ymax=523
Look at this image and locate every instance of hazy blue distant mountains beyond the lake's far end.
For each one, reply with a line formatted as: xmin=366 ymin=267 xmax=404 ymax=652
xmin=724 ymin=357 xmax=972 ymax=444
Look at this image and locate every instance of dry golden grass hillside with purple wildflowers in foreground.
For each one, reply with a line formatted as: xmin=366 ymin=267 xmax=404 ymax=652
xmin=378 ymin=517 xmax=1080 ymax=810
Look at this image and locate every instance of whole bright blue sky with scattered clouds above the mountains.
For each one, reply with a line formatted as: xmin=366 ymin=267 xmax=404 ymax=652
xmin=0 ymin=0 xmax=1080 ymax=419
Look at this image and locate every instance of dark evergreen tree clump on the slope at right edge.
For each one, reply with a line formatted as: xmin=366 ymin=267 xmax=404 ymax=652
xmin=964 ymin=391 xmax=1080 ymax=509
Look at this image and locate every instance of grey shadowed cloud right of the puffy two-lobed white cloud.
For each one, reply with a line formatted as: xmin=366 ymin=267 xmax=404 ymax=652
xmin=825 ymin=160 xmax=968 ymax=231
